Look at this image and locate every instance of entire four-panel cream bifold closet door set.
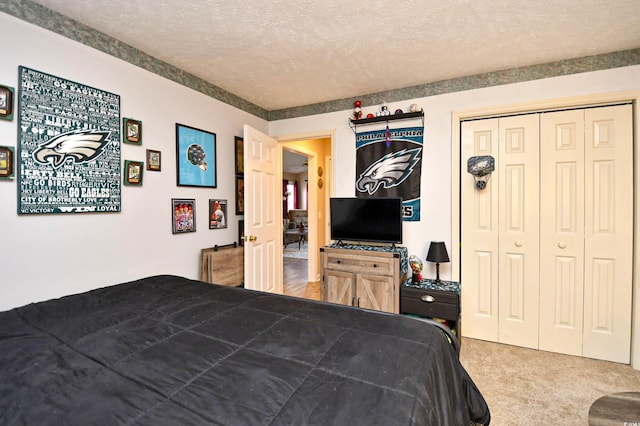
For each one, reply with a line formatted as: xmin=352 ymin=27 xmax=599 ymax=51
xmin=461 ymin=105 xmax=633 ymax=363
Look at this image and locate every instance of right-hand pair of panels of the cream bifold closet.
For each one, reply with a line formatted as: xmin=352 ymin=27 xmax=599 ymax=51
xmin=540 ymin=105 xmax=633 ymax=364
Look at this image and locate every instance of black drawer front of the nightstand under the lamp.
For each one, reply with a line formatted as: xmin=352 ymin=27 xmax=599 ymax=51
xmin=400 ymin=287 xmax=460 ymax=321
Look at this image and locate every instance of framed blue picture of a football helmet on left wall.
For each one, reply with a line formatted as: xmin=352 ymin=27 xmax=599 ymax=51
xmin=176 ymin=123 xmax=217 ymax=188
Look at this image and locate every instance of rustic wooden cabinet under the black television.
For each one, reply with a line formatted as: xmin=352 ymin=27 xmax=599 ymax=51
xmin=320 ymin=242 xmax=409 ymax=314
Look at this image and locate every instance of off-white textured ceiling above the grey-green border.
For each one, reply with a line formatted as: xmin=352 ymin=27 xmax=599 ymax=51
xmin=28 ymin=0 xmax=640 ymax=111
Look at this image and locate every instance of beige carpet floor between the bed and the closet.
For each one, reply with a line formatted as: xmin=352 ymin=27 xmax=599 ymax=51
xmin=460 ymin=337 xmax=640 ymax=426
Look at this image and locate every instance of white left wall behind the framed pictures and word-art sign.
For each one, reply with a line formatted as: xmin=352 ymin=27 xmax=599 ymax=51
xmin=0 ymin=13 xmax=267 ymax=310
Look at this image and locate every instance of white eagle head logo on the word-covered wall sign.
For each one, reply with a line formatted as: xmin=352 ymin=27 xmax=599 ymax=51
xmin=33 ymin=130 xmax=111 ymax=169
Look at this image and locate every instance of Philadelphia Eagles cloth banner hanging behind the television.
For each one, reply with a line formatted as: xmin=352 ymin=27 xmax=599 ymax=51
xmin=356 ymin=127 xmax=424 ymax=221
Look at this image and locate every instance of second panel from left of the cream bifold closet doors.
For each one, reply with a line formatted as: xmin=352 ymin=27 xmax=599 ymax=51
xmin=496 ymin=114 xmax=540 ymax=348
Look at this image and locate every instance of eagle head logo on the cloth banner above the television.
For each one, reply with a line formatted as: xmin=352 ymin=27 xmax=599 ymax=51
xmin=356 ymin=148 xmax=422 ymax=195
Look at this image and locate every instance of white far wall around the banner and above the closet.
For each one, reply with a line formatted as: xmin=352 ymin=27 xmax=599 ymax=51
xmin=269 ymin=66 xmax=640 ymax=279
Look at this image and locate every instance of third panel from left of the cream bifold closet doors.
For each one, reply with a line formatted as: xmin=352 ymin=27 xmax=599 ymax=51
xmin=540 ymin=110 xmax=585 ymax=356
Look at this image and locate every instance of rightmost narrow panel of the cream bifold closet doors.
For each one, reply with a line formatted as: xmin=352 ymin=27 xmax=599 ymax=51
xmin=583 ymin=105 xmax=633 ymax=364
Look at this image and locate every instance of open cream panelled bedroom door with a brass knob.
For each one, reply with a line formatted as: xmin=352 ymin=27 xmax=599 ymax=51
xmin=244 ymin=125 xmax=283 ymax=294
